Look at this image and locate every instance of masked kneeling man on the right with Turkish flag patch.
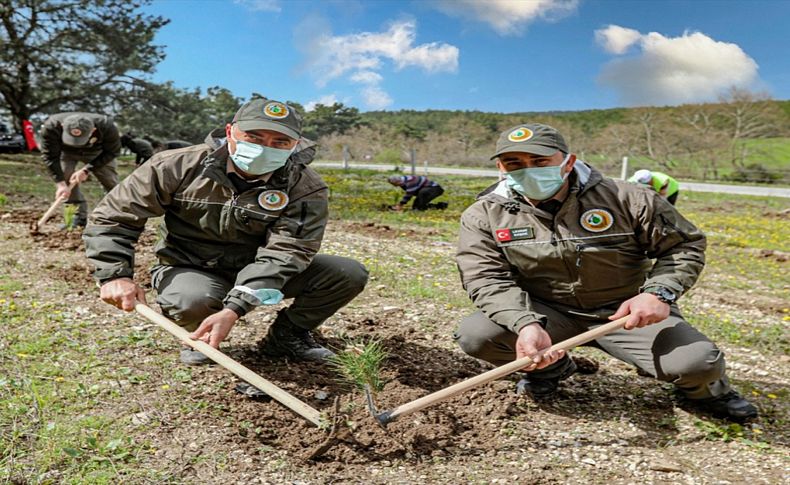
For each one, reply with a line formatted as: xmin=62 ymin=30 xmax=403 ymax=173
xmin=455 ymin=123 xmax=757 ymax=420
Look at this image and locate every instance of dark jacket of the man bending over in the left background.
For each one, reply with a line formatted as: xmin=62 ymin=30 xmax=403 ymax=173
xmin=40 ymin=113 xmax=121 ymax=182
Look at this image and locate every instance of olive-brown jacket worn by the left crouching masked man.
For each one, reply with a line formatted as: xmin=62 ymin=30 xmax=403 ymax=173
xmin=83 ymin=131 xmax=328 ymax=315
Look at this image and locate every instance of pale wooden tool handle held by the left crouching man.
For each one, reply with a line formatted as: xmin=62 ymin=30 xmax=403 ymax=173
xmin=134 ymin=303 xmax=322 ymax=426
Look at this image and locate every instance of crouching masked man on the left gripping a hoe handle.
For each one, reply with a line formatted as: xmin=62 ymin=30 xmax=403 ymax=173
xmin=83 ymin=98 xmax=367 ymax=364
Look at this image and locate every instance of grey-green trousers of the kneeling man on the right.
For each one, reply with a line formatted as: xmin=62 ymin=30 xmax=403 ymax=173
xmin=454 ymin=300 xmax=730 ymax=399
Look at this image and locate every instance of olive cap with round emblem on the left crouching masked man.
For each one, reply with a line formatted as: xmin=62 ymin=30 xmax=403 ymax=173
xmin=233 ymin=98 xmax=302 ymax=140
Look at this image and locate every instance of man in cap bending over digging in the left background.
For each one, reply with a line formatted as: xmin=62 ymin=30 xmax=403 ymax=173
xmin=40 ymin=112 xmax=121 ymax=228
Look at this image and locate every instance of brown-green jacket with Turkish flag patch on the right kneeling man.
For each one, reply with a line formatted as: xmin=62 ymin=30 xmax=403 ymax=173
xmin=457 ymin=161 xmax=706 ymax=333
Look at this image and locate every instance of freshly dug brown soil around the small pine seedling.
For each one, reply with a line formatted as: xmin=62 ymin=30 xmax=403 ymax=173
xmin=175 ymin=313 xmax=632 ymax=471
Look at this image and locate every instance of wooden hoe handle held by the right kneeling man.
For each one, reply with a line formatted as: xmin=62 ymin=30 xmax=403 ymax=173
xmin=387 ymin=315 xmax=630 ymax=421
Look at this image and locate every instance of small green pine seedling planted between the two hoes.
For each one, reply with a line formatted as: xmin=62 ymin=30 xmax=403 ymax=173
xmin=329 ymin=340 xmax=388 ymax=393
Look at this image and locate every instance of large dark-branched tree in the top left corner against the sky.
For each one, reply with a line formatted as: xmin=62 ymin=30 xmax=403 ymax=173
xmin=0 ymin=0 xmax=169 ymax=127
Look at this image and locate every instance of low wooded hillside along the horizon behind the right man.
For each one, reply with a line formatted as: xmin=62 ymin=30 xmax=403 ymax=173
xmin=316 ymin=95 xmax=790 ymax=183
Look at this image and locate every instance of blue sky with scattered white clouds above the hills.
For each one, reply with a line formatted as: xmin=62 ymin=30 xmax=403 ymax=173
xmin=145 ymin=0 xmax=790 ymax=113
